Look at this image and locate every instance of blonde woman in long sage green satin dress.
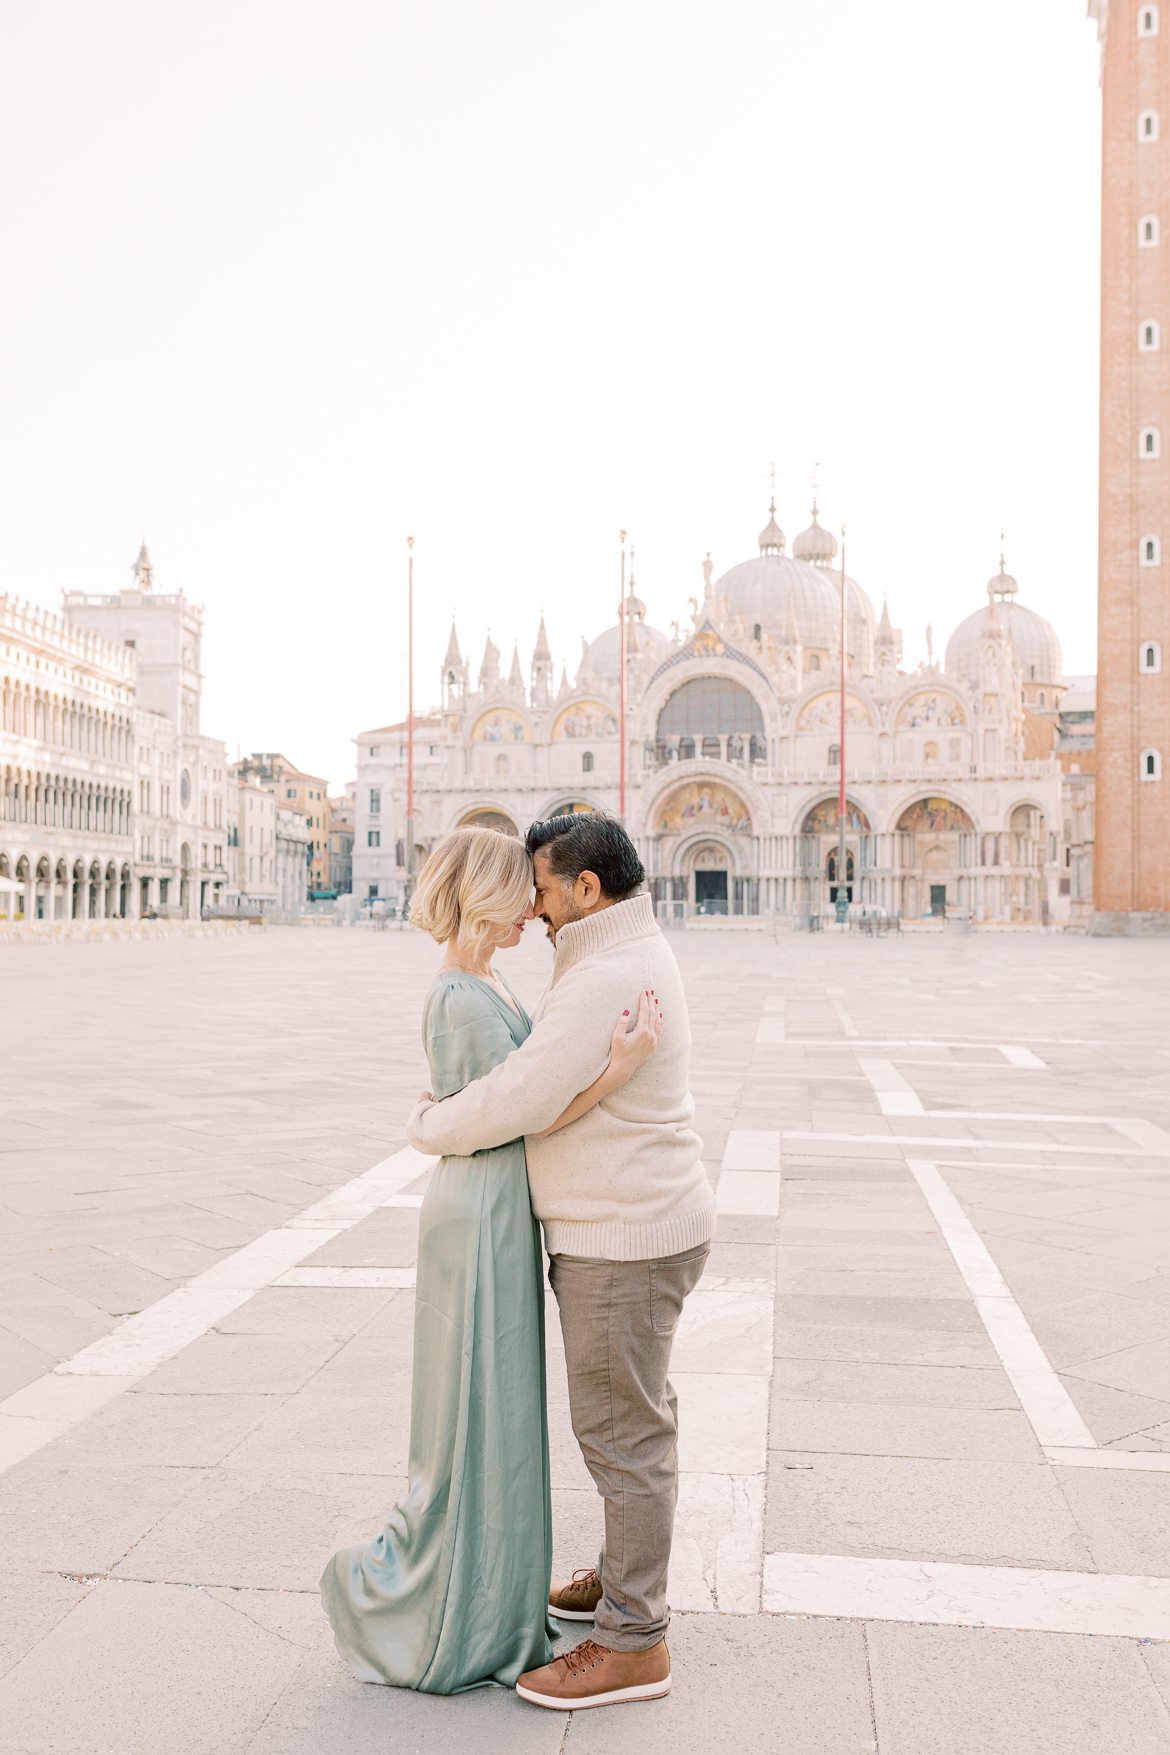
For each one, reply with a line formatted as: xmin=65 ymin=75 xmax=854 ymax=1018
xmin=321 ymin=828 xmax=658 ymax=1694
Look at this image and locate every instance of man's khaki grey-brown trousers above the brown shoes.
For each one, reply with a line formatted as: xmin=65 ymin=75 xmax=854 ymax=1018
xmin=549 ymin=1243 xmax=710 ymax=1651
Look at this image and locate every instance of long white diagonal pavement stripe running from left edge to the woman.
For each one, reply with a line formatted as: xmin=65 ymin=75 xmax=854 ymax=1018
xmin=0 ymin=1146 xmax=433 ymax=1471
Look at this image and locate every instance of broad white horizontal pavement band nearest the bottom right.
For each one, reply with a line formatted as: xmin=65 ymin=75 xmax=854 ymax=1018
xmin=763 ymin=1553 xmax=1170 ymax=1639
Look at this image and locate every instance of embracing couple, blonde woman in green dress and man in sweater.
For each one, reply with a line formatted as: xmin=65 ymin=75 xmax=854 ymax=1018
xmin=321 ymin=814 xmax=714 ymax=1711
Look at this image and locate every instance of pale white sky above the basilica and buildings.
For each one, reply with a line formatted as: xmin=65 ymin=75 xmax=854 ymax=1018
xmin=0 ymin=0 xmax=1100 ymax=788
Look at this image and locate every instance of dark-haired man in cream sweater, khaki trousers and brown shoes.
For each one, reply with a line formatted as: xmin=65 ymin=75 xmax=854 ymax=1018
xmin=407 ymin=813 xmax=714 ymax=1711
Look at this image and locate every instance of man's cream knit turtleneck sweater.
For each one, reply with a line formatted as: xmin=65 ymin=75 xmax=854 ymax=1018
xmin=407 ymin=895 xmax=716 ymax=1262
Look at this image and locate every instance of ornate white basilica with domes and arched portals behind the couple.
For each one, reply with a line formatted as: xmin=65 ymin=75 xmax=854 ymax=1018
xmin=354 ymin=505 xmax=1089 ymax=925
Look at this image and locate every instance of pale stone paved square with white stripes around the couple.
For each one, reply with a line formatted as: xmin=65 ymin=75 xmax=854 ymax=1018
xmin=0 ymin=925 xmax=1170 ymax=1755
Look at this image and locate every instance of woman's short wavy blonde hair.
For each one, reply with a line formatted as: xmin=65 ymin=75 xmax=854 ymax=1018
xmin=410 ymin=828 xmax=531 ymax=962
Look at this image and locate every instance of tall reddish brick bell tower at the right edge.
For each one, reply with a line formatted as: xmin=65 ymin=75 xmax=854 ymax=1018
xmin=1089 ymin=0 xmax=1170 ymax=934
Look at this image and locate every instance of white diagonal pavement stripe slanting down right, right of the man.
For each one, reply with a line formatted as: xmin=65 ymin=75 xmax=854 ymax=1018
xmin=909 ymin=1158 xmax=1096 ymax=1450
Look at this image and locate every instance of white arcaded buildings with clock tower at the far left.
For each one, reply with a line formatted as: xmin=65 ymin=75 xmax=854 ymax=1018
xmin=0 ymin=544 xmax=226 ymax=921
